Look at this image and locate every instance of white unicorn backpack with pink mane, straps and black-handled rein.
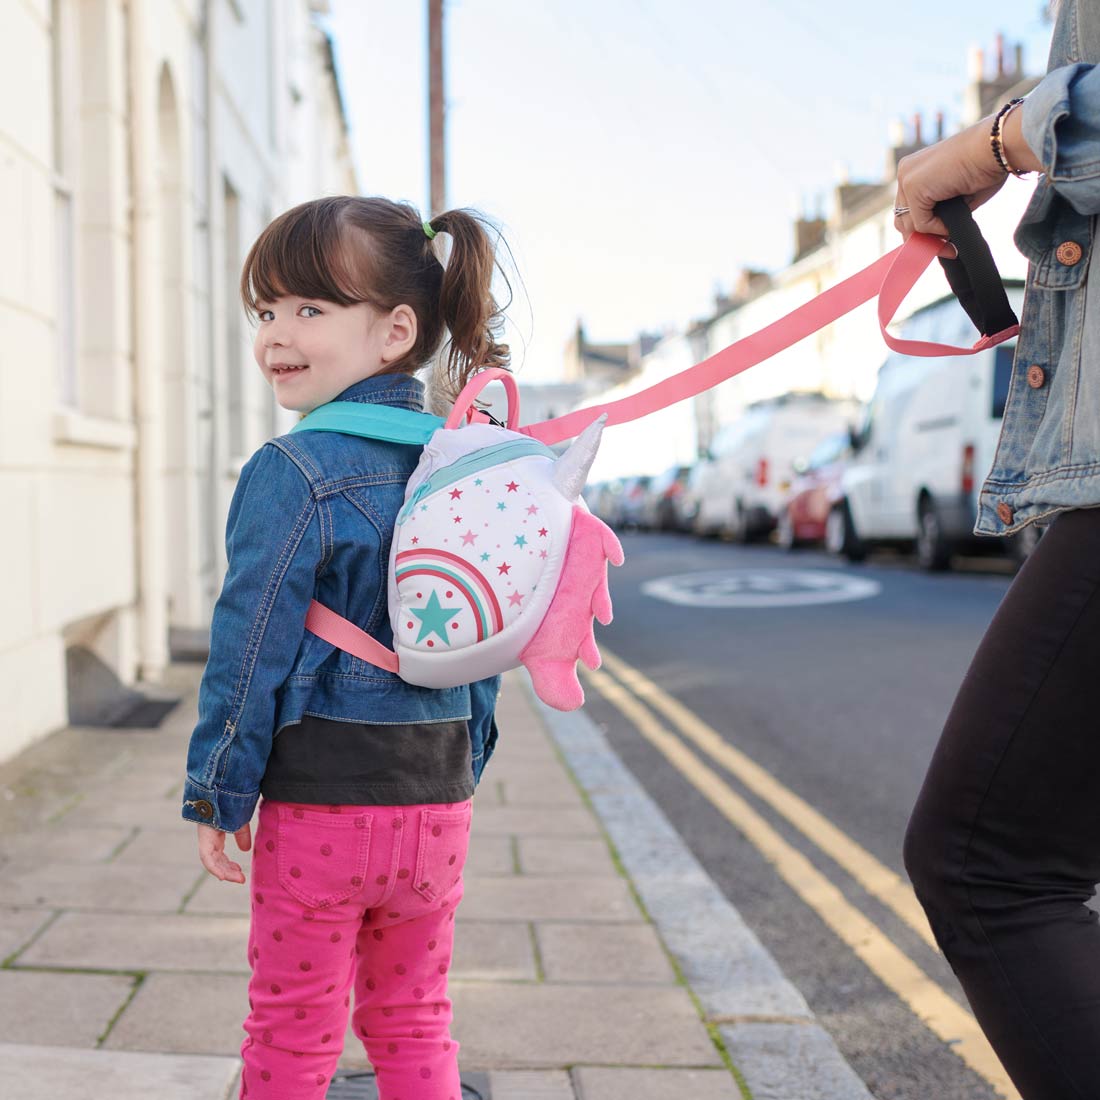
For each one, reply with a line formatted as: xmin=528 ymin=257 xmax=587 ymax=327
xmin=293 ymin=199 xmax=1020 ymax=711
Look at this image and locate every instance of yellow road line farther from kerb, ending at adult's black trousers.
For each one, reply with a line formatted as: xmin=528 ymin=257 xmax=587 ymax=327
xmin=601 ymin=649 xmax=939 ymax=952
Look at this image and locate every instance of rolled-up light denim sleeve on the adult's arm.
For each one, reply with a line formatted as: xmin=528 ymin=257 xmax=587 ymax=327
xmin=1021 ymin=64 xmax=1100 ymax=216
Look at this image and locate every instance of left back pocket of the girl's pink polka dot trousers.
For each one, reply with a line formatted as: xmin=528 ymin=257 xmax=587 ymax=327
xmin=277 ymin=805 xmax=371 ymax=909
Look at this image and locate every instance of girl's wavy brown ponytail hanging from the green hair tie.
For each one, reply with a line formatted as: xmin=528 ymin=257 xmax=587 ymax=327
xmin=426 ymin=210 xmax=512 ymax=403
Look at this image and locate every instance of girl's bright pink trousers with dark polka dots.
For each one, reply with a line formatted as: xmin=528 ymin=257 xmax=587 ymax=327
xmin=240 ymin=800 xmax=471 ymax=1100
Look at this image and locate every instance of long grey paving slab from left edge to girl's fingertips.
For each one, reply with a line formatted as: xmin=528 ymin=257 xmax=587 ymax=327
xmin=0 ymin=861 xmax=204 ymax=913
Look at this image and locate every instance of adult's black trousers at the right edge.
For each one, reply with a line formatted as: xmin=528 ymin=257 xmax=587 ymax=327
xmin=905 ymin=508 xmax=1100 ymax=1100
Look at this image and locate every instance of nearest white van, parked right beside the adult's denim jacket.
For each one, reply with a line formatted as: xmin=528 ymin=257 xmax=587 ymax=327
xmin=825 ymin=287 xmax=1038 ymax=570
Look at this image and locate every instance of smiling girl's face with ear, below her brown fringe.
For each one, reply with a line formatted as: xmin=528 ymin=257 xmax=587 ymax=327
xmin=252 ymin=295 xmax=416 ymax=413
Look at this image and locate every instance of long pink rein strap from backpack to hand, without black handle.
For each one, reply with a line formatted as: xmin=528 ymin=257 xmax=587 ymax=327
xmin=518 ymin=233 xmax=1020 ymax=443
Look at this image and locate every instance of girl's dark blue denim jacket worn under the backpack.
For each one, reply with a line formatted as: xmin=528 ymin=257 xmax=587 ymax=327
xmin=183 ymin=375 xmax=501 ymax=832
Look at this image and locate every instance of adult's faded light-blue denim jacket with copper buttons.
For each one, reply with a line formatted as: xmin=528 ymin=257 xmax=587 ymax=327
xmin=975 ymin=0 xmax=1100 ymax=535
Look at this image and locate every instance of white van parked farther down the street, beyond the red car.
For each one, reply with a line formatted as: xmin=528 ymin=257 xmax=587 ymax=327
xmin=691 ymin=393 xmax=859 ymax=542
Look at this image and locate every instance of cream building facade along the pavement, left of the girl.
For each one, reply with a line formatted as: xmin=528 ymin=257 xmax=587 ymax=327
xmin=0 ymin=0 xmax=355 ymax=760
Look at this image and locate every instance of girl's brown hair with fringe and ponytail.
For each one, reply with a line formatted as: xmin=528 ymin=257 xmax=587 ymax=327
xmin=241 ymin=195 xmax=510 ymax=402
